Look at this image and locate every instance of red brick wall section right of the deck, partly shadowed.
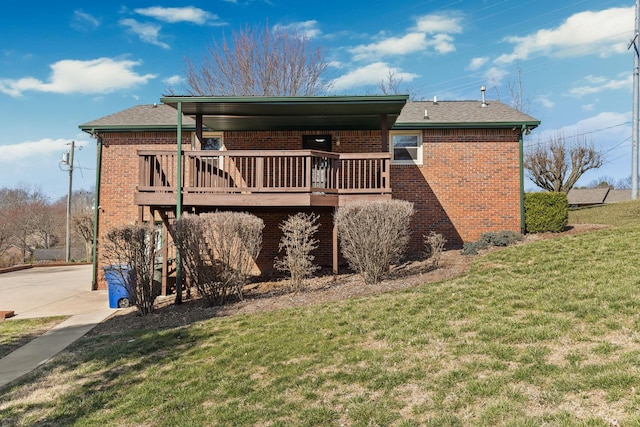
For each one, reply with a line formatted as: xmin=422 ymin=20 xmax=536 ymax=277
xmin=391 ymin=129 xmax=520 ymax=247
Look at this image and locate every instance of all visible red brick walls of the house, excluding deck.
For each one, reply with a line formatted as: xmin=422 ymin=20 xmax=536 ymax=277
xmin=98 ymin=129 xmax=520 ymax=288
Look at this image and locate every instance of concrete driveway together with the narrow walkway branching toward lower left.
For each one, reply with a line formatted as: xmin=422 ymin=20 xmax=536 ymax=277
xmin=0 ymin=265 xmax=116 ymax=388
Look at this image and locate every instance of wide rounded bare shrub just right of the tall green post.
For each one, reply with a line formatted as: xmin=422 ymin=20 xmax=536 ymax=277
xmin=174 ymin=212 xmax=264 ymax=305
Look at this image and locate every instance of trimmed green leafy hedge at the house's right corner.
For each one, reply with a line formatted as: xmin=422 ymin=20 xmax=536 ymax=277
xmin=524 ymin=192 xmax=569 ymax=233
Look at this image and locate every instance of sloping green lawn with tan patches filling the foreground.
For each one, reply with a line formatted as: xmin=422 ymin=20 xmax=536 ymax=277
xmin=0 ymin=205 xmax=640 ymax=426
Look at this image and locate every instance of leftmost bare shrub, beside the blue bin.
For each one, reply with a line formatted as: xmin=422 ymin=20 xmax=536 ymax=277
xmin=103 ymin=224 xmax=159 ymax=316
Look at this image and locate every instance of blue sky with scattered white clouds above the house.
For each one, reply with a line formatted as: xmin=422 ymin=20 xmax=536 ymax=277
xmin=0 ymin=0 xmax=634 ymax=199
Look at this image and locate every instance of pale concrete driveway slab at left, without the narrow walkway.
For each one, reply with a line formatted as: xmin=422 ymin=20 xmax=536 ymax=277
xmin=0 ymin=265 xmax=109 ymax=319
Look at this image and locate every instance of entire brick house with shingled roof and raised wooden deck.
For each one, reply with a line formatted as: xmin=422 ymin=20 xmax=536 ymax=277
xmin=80 ymin=95 xmax=540 ymax=293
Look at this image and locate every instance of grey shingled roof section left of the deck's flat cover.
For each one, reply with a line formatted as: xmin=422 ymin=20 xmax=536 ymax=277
xmin=80 ymin=104 xmax=196 ymax=132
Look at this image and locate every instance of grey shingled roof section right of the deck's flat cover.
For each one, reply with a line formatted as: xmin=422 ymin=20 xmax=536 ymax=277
xmin=394 ymin=101 xmax=540 ymax=129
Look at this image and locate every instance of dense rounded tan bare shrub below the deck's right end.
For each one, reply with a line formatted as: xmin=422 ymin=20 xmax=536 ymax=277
xmin=335 ymin=200 xmax=414 ymax=284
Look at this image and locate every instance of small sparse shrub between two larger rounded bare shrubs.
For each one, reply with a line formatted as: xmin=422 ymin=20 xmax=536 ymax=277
xmin=273 ymin=212 xmax=320 ymax=291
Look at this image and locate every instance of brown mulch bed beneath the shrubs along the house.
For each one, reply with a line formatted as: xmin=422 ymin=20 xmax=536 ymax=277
xmin=91 ymin=224 xmax=607 ymax=334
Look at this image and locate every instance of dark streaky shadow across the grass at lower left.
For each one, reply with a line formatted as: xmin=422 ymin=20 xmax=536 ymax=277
xmin=0 ymin=307 xmax=218 ymax=426
